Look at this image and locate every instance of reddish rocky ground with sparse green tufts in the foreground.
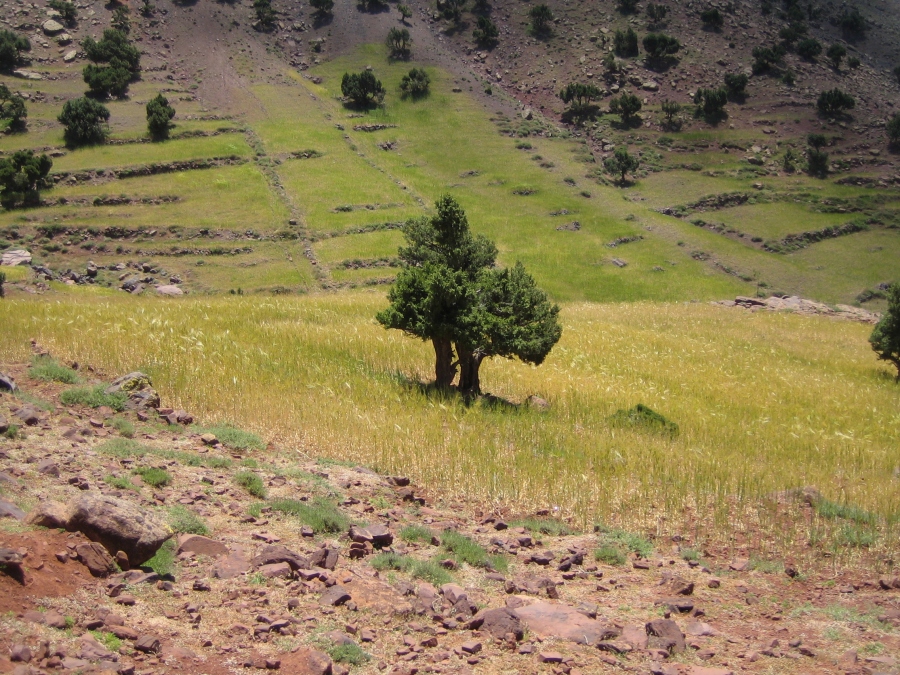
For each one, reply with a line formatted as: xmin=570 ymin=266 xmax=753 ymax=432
xmin=0 ymin=354 xmax=900 ymax=675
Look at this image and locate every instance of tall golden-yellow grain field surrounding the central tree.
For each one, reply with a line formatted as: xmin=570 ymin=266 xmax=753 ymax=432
xmin=0 ymin=293 xmax=900 ymax=564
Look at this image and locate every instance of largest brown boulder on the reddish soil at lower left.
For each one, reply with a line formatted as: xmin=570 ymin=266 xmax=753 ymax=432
xmin=65 ymin=494 xmax=172 ymax=565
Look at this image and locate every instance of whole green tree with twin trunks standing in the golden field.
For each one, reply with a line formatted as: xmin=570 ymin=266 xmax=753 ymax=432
xmin=376 ymin=195 xmax=562 ymax=394
